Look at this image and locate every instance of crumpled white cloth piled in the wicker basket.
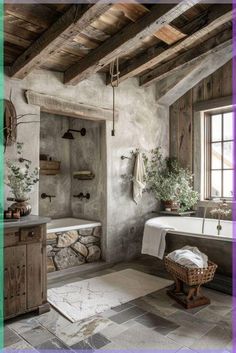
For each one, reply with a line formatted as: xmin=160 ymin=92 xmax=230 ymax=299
xmin=167 ymin=246 xmax=208 ymax=268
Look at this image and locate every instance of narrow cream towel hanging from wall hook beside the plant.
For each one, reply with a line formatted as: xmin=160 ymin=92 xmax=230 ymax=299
xmin=133 ymin=152 xmax=146 ymax=203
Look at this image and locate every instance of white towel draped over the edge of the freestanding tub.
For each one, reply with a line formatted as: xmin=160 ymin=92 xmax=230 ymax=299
xmin=142 ymin=218 xmax=174 ymax=259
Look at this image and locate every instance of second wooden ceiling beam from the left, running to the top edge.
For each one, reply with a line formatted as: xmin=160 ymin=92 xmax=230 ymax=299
xmin=65 ymin=0 xmax=200 ymax=84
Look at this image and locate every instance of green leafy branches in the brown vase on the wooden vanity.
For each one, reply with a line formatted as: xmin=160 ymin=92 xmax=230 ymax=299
xmin=6 ymin=142 xmax=39 ymax=200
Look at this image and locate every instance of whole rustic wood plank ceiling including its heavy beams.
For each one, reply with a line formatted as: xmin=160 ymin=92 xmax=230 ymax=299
xmin=4 ymin=0 xmax=232 ymax=85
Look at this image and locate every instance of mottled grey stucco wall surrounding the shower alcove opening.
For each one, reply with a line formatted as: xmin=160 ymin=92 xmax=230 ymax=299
xmin=6 ymin=70 xmax=169 ymax=261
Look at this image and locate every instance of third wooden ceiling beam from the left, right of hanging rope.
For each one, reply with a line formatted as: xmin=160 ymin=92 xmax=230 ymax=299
xmin=114 ymin=4 xmax=232 ymax=84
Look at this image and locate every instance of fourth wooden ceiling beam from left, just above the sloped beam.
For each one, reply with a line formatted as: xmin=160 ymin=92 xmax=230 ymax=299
xmin=140 ymin=29 xmax=232 ymax=86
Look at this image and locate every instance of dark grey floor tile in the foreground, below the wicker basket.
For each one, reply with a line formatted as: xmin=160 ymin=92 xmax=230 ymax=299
xmin=135 ymin=313 xmax=179 ymax=335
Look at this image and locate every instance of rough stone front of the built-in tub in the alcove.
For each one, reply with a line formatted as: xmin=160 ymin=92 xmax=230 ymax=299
xmin=47 ymin=226 xmax=102 ymax=272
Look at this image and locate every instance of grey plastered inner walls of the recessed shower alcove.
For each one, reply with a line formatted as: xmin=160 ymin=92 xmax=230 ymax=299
xmin=39 ymin=112 xmax=105 ymax=220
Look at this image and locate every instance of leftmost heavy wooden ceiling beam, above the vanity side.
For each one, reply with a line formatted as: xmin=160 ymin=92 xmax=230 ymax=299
xmin=8 ymin=1 xmax=112 ymax=79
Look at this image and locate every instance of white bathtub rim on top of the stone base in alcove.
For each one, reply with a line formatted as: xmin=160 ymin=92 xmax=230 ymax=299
xmin=47 ymin=218 xmax=101 ymax=233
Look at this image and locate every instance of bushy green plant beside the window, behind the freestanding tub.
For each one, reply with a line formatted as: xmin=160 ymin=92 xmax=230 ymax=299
xmin=144 ymin=147 xmax=199 ymax=212
